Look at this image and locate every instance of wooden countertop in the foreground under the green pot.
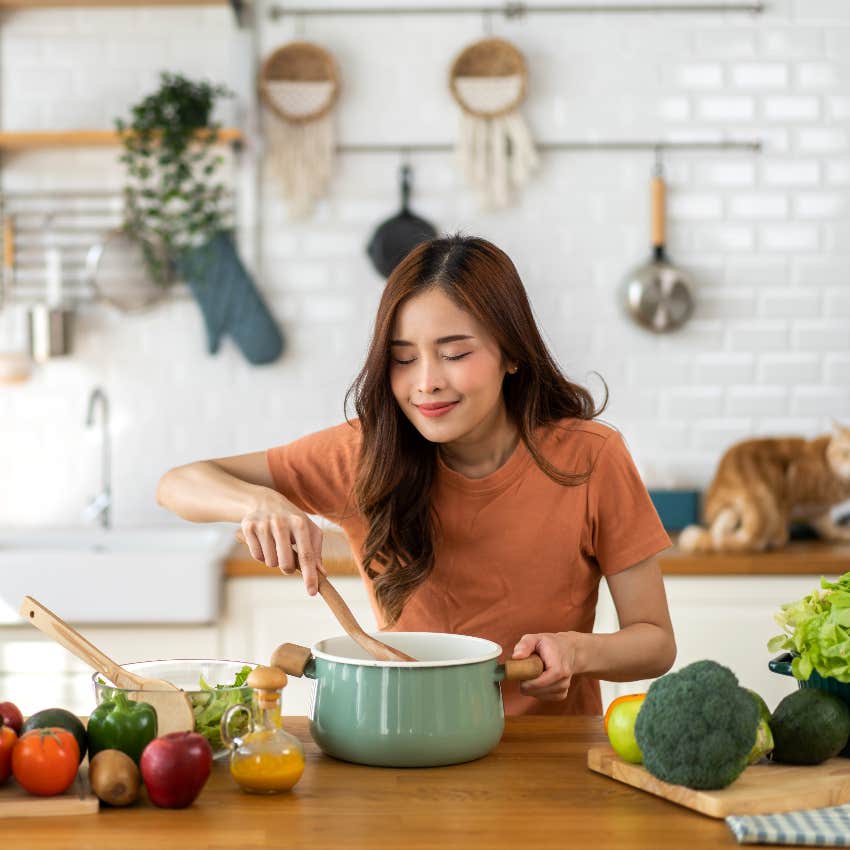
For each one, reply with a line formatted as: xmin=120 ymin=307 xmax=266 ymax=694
xmin=2 ymin=717 xmax=737 ymax=850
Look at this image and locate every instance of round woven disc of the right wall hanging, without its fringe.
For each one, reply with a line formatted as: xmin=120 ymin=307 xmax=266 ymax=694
xmin=449 ymin=38 xmax=528 ymax=118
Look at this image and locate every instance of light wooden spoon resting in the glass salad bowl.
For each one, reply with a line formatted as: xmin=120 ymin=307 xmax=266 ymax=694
xmin=19 ymin=596 xmax=195 ymax=735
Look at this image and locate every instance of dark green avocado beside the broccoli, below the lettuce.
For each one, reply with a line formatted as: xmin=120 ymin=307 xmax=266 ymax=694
xmin=770 ymin=688 xmax=850 ymax=764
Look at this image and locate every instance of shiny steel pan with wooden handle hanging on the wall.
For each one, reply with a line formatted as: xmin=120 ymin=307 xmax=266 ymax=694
xmin=621 ymin=160 xmax=694 ymax=333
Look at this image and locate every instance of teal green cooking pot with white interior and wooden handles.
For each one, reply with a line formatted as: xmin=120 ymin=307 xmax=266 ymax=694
xmin=284 ymin=632 xmax=542 ymax=767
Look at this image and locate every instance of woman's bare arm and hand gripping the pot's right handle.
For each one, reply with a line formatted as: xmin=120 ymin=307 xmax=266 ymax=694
xmin=513 ymin=558 xmax=676 ymax=700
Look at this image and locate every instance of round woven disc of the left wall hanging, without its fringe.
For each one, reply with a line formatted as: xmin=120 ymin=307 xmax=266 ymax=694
xmin=258 ymin=41 xmax=339 ymax=124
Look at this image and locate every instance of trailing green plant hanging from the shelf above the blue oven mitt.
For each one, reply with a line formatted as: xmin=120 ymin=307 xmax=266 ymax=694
xmin=115 ymin=71 xmax=232 ymax=286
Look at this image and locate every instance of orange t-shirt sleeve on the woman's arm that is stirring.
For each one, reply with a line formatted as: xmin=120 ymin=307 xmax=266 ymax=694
xmin=266 ymin=421 xmax=360 ymax=522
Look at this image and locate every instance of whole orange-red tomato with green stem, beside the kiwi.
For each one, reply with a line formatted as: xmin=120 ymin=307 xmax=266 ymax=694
xmin=12 ymin=726 xmax=80 ymax=797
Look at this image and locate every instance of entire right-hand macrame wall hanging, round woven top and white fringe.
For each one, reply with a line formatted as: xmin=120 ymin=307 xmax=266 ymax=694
xmin=449 ymin=38 xmax=539 ymax=209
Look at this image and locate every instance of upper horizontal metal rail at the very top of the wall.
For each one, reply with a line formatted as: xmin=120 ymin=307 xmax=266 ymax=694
xmin=268 ymin=0 xmax=764 ymax=21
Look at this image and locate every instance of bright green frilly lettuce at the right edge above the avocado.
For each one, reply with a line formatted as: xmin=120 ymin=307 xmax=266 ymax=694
xmin=767 ymin=573 xmax=850 ymax=682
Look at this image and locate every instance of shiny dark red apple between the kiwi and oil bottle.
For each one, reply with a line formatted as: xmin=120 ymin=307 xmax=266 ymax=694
xmin=139 ymin=732 xmax=212 ymax=809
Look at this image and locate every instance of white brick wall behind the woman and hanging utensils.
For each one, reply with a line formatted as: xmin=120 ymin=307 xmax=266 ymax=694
xmin=0 ymin=0 xmax=850 ymax=525
